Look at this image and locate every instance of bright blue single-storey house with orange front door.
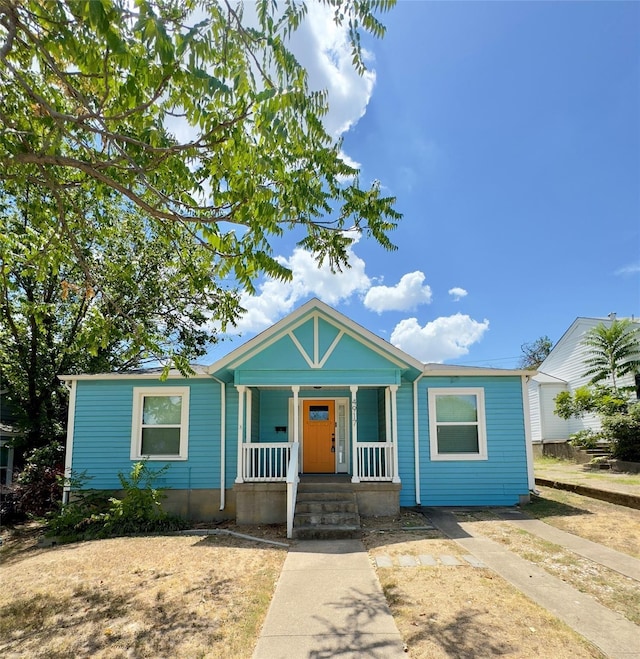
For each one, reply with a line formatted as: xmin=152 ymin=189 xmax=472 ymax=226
xmin=63 ymin=299 xmax=534 ymax=531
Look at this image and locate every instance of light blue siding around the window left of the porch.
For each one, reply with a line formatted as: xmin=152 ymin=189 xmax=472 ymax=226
xmin=73 ymin=379 xmax=220 ymax=489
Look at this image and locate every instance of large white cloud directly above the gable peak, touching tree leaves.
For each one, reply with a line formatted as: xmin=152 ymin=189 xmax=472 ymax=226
xmin=236 ymin=236 xmax=371 ymax=333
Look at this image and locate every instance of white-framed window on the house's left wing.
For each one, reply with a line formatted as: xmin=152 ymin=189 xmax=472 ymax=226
xmin=131 ymin=387 xmax=189 ymax=460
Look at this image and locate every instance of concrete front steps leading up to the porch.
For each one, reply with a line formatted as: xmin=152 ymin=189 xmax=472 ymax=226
xmin=293 ymin=477 xmax=362 ymax=540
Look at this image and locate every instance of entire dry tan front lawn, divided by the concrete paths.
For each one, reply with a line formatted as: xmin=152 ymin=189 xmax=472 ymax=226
xmin=0 ymin=489 xmax=640 ymax=659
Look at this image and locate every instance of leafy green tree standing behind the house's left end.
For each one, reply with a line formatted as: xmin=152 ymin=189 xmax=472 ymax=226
xmin=0 ymin=188 xmax=238 ymax=449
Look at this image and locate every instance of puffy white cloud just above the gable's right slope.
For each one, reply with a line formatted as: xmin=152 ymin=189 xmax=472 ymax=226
xmin=391 ymin=313 xmax=489 ymax=363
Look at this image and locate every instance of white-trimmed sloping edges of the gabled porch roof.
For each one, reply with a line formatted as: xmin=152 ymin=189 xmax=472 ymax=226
xmin=208 ymin=298 xmax=424 ymax=375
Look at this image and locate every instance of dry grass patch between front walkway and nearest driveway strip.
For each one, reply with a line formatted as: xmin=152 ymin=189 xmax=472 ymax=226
xmin=364 ymin=513 xmax=603 ymax=659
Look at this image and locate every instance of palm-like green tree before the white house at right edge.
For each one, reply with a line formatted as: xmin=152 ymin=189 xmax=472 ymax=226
xmin=582 ymin=318 xmax=640 ymax=393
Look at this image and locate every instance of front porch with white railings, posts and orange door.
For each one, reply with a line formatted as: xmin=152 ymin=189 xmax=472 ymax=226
xmin=235 ymin=385 xmax=400 ymax=485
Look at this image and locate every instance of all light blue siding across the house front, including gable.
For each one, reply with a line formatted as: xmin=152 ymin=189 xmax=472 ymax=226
xmin=73 ymin=304 xmax=528 ymax=506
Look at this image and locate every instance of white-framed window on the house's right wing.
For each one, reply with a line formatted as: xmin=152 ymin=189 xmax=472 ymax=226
xmin=429 ymin=388 xmax=487 ymax=460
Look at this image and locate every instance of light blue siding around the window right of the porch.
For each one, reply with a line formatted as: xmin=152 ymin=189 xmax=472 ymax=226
xmin=410 ymin=376 xmax=529 ymax=506
